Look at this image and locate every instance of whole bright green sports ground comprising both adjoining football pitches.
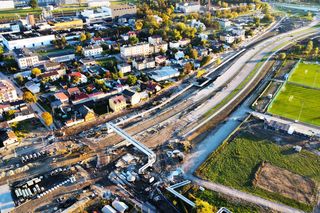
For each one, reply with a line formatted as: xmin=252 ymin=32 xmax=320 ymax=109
xmin=268 ymin=63 xmax=320 ymax=126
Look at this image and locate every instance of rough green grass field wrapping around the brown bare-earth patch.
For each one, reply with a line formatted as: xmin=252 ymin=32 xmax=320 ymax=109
xmin=197 ymin=133 xmax=320 ymax=212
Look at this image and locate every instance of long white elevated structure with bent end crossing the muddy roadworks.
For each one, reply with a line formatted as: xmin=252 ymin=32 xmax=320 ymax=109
xmin=107 ymin=123 xmax=156 ymax=174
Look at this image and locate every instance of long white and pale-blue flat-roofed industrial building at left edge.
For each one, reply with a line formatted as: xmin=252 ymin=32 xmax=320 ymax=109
xmin=2 ymin=32 xmax=55 ymax=50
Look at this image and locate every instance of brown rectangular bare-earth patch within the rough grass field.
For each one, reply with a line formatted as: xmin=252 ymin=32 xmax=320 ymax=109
xmin=253 ymin=163 xmax=318 ymax=205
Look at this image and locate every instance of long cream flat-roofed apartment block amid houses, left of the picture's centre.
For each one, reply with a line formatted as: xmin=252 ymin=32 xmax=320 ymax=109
xmin=120 ymin=43 xmax=151 ymax=58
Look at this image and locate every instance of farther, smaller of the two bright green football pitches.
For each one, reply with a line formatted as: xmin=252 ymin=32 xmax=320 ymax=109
xmin=289 ymin=63 xmax=320 ymax=88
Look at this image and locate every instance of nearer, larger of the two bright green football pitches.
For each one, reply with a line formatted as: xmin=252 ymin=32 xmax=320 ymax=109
xmin=268 ymin=83 xmax=320 ymax=125
